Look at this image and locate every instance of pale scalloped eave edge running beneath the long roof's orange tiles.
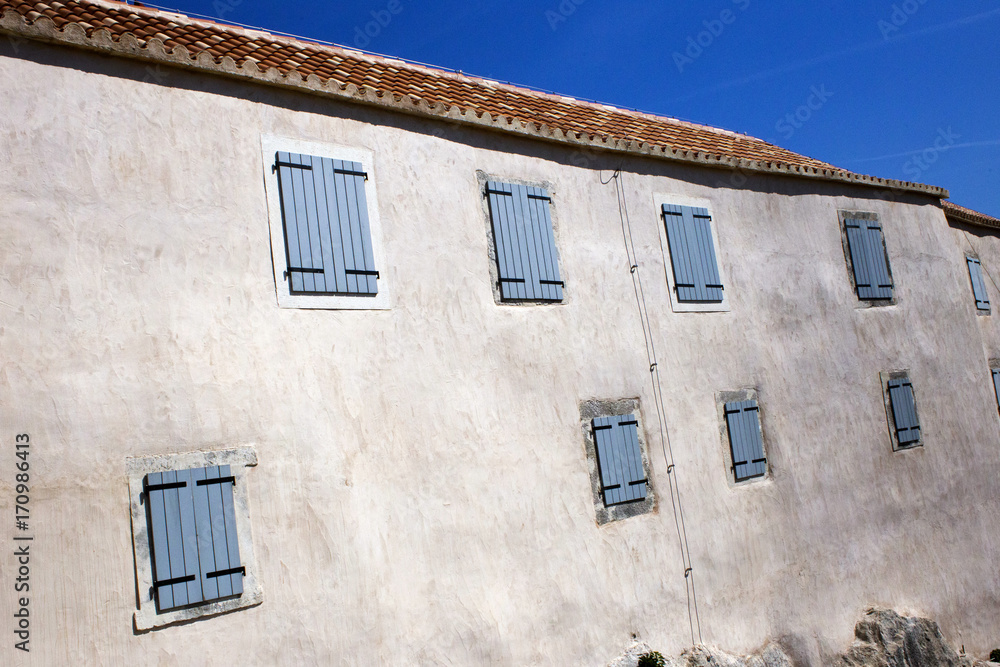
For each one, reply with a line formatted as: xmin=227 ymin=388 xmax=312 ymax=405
xmin=0 ymin=10 xmax=949 ymax=199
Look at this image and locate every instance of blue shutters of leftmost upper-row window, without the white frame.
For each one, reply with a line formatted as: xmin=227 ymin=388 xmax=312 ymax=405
xmin=274 ymin=152 xmax=379 ymax=296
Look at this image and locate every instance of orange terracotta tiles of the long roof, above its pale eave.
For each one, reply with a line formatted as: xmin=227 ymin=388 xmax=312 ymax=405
xmin=0 ymin=0 xmax=947 ymax=196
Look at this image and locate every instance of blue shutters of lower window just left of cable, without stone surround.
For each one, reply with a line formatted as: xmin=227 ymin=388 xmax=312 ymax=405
xmin=591 ymin=415 xmax=649 ymax=507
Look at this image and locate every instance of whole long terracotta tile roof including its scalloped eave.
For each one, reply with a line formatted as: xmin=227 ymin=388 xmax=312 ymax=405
xmin=0 ymin=0 xmax=947 ymax=197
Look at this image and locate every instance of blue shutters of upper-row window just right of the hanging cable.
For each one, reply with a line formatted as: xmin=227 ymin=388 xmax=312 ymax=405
xmin=663 ymin=204 xmax=724 ymax=303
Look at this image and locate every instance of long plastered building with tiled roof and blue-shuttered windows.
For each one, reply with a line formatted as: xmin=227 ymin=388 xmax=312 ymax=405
xmin=0 ymin=0 xmax=1000 ymax=665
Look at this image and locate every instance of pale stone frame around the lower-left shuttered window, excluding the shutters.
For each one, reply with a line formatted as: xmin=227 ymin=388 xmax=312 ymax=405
xmin=126 ymin=446 xmax=264 ymax=632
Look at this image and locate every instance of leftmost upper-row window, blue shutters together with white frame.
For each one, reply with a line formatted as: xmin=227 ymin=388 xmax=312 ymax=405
xmin=264 ymin=137 xmax=388 ymax=309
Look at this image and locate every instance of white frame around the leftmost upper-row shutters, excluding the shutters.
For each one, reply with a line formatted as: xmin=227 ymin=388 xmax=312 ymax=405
xmin=261 ymin=134 xmax=392 ymax=310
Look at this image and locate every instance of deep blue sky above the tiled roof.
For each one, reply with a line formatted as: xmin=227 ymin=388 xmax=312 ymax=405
xmin=150 ymin=0 xmax=1000 ymax=217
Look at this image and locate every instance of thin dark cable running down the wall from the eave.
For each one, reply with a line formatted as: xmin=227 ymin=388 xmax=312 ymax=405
xmin=601 ymin=167 xmax=702 ymax=644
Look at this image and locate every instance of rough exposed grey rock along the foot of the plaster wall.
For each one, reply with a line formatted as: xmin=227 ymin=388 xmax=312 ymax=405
xmin=608 ymin=609 xmax=997 ymax=667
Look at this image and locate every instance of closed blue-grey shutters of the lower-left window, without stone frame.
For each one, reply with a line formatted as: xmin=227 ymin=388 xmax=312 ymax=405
xmin=145 ymin=466 xmax=245 ymax=612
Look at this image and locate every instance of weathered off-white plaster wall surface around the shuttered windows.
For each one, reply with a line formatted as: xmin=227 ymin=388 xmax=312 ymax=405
xmin=0 ymin=44 xmax=1000 ymax=665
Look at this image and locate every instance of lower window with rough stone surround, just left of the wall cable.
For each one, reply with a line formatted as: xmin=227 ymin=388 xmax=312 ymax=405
xmin=580 ymin=398 xmax=656 ymax=525
